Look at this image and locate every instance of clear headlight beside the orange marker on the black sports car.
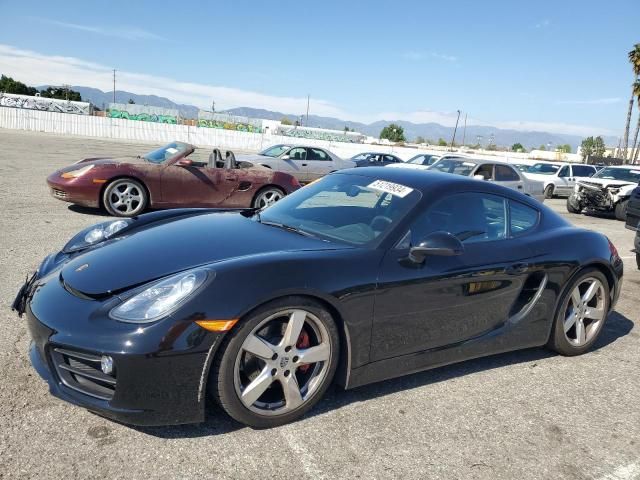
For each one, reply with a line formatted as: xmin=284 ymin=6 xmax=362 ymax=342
xmin=109 ymin=268 xmax=213 ymax=323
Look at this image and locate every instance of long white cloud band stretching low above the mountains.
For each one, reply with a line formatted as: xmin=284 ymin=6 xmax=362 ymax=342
xmin=0 ymin=44 xmax=613 ymax=135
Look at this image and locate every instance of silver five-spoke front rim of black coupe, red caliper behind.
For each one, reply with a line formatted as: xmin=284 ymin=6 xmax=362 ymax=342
xmin=234 ymin=309 xmax=332 ymax=415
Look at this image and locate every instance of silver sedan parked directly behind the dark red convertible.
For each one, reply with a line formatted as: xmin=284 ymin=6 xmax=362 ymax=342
xmin=237 ymin=144 xmax=356 ymax=183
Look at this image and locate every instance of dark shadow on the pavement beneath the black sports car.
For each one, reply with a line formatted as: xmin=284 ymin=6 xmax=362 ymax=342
xmin=138 ymin=311 xmax=634 ymax=439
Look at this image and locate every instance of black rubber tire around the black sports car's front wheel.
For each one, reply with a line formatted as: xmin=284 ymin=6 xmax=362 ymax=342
xmin=208 ymin=296 xmax=340 ymax=428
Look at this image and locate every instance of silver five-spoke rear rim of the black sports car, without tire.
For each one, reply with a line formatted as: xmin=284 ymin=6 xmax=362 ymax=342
xmin=564 ymin=277 xmax=606 ymax=347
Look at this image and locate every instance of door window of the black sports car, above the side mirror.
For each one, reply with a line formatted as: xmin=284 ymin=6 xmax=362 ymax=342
xmin=410 ymin=193 xmax=507 ymax=245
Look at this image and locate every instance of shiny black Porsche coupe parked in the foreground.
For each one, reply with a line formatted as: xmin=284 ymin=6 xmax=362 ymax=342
xmin=14 ymin=168 xmax=622 ymax=427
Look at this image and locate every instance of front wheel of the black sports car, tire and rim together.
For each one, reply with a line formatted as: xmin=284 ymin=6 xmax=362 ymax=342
xmin=209 ymin=297 xmax=340 ymax=428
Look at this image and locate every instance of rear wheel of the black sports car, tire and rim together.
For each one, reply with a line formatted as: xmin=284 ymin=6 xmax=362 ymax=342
xmin=548 ymin=268 xmax=610 ymax=356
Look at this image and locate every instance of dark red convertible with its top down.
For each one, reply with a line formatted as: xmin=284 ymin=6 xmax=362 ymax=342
xmin=47 ymin=142 xmax=300 ymax=217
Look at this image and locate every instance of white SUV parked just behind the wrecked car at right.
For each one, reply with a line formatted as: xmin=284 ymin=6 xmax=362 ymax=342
xmin=525 ymin=162 xmax=597 ymax=198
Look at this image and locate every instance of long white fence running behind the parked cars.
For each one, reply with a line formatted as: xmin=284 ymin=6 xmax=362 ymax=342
xmin=0 ymin=107 xmax=580 ymax=161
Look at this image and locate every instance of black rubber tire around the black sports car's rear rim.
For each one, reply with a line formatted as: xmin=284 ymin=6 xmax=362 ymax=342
xmin=547 ymin=267 xmax=611 ymax=357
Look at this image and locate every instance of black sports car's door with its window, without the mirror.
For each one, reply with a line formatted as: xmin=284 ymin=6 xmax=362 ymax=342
xmin=371 ymin=193 xmax=532 ymax=361
